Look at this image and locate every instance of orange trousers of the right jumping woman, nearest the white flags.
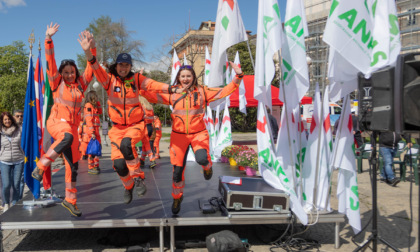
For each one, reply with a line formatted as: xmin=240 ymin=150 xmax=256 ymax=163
xmin=169 ymin=130 xmax=213 ymax=199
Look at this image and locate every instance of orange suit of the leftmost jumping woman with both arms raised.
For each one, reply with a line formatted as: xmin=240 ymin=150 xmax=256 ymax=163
xmin=37 ymin=39 xmax=96 ymax=204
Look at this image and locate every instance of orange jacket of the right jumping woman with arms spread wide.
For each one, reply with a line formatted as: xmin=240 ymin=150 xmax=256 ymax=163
xmin=144 ymin=81 xmax=239 ymax=134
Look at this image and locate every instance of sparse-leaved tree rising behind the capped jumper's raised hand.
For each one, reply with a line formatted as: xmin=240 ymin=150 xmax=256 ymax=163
xmin=77 ymin=16 xmax=144 ymax=67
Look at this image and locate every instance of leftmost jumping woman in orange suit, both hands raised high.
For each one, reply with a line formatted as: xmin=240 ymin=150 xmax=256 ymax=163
xmin=32 ymin=23 xmax=96 ymax=217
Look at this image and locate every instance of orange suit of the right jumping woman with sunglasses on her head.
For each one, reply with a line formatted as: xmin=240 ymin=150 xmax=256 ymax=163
xmin=145 ymin=82 xmax=239 ymax=199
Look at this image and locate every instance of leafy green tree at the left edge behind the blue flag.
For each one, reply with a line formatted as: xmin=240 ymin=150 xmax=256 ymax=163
xmin=0 ymin=41 xmax=28 ymax=112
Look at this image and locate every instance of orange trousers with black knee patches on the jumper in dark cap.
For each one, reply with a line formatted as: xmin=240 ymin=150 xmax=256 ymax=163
xmin=108 ymin=121 xmax=145 ymax=190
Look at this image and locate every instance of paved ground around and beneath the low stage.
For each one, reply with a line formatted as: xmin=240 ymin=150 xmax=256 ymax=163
xmin=3 ymin=129 xmax=419 ymax=252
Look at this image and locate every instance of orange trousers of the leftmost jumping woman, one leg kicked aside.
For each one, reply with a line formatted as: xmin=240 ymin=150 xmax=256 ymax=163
xmin=36 ymin=117 xmax=80 ymax=204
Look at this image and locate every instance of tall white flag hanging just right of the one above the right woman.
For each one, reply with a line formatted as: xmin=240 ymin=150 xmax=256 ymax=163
xmin=254 ymin=0 xmax=283 ymax=110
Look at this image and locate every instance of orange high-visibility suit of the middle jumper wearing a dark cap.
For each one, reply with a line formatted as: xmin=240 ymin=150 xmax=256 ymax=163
xmin=89 ymin=58 xmax=170 ymax=190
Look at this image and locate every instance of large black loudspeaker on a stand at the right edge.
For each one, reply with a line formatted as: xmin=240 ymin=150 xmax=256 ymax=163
xmin=358 ymin=53 xmax=420 ymax=133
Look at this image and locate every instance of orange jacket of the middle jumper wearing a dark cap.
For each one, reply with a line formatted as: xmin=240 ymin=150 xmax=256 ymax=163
xmin=89 ymin=60 xmax=169 ymax=125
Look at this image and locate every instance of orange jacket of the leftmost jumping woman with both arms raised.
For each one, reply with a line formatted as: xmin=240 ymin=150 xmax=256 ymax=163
xmin=45 ymin=39 xmax=96 ymax=126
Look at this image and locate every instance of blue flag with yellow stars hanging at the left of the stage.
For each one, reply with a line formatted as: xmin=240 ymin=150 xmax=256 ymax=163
xmin=21 ymin=55 xmax=40 ymax=199
